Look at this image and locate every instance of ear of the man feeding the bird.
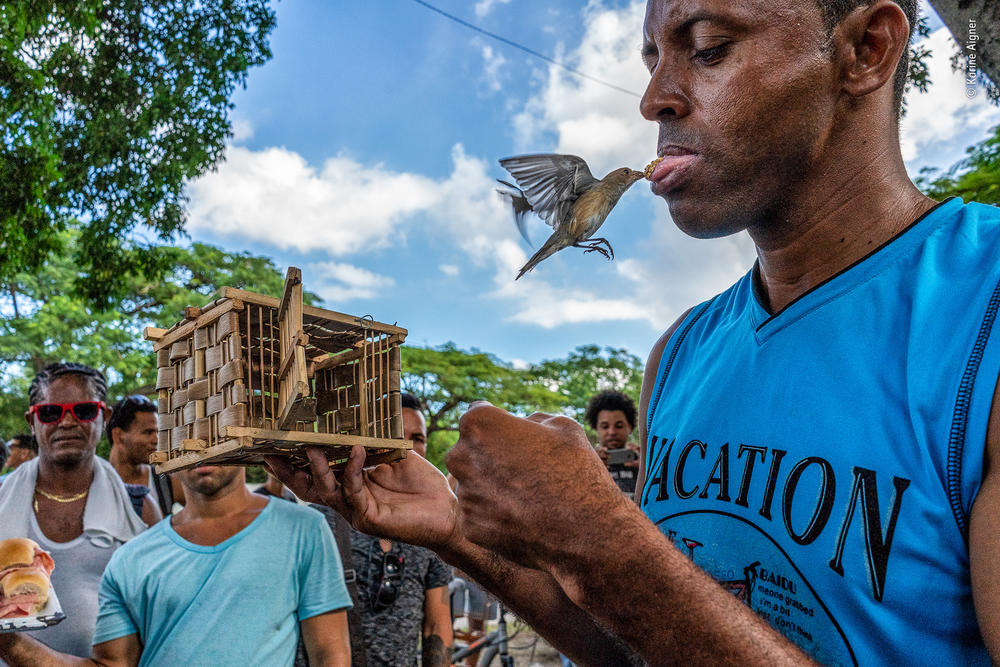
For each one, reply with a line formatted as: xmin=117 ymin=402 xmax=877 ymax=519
xmin=834 ymin=0 xmax=910 ymax=97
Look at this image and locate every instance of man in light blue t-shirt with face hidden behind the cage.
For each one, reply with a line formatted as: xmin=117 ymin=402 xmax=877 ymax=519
xmin=0 ymin=466 xmax=351 ymax=666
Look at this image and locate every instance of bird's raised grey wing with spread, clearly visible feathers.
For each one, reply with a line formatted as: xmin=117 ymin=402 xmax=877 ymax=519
xmin=500 ymin=153 xmax=597 ymax=228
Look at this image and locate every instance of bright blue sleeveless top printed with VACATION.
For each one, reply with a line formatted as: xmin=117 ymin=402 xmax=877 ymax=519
xmin=640 ymin=199 xmax=1000 ymax=665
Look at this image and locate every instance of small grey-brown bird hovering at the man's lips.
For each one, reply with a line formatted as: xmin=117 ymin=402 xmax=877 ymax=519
xmin=497 ymin=153 xmax=646 ymax=280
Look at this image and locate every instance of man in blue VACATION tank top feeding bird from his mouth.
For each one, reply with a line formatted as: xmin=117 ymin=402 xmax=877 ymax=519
xmin=270 ymin=0 xmax=1000 ymax=665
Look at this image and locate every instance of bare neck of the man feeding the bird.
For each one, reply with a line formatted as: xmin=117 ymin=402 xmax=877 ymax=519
xmin=748 ymin=127 xmax=935 ymax=313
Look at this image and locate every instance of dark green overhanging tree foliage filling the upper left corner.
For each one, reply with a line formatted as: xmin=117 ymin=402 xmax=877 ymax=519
xmin=0 ymin=0 xmax=275 ymax=307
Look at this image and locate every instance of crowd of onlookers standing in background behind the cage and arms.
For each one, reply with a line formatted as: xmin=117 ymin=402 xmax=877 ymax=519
xmin=0 ymin=362 xmax=637 ymax=666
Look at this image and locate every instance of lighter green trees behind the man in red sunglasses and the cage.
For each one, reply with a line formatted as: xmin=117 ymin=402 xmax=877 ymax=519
xmin=0 ymin=225 xmax=319 ymax=437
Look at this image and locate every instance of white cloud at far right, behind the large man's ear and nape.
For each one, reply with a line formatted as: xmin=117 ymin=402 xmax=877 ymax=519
xmin=900 ymin=28 xmax=1000 ymax=166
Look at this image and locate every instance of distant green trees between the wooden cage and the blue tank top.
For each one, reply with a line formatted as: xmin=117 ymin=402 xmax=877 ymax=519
xmin=403 ymin=343 xmax=643 ymax=469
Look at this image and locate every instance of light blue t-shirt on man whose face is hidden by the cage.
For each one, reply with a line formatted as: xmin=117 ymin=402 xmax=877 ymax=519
xmin=94 ymin=498 xmax=351 ymax=667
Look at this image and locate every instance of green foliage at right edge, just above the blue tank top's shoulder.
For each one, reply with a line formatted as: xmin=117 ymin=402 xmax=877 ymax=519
xmin=916 ymin=125 xmax=1000 ymax=206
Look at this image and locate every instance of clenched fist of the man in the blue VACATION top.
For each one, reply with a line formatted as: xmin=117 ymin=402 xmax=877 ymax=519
xmin=447 ymin=403 xmax=627 ymax=569
